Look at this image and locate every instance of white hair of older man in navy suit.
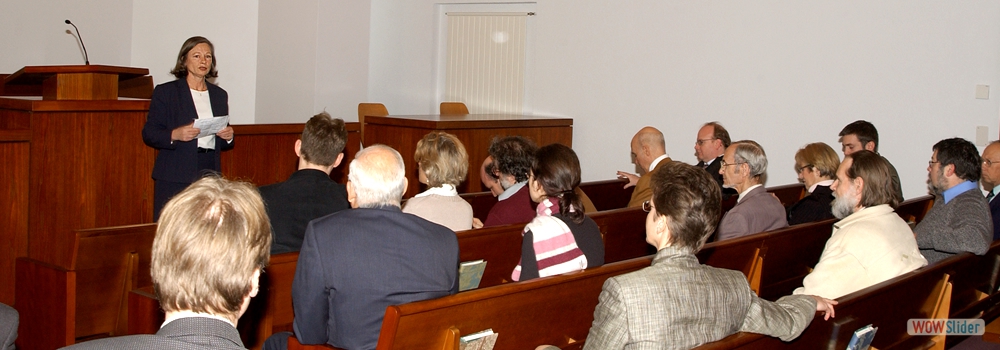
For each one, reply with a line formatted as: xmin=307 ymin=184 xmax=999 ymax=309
xmin=347 ymin=145 xmax=406 ymax=208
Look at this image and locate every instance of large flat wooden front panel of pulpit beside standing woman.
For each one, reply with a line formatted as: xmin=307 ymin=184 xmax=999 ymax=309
xmin=28 ymin=111 xmax=154 ymax=267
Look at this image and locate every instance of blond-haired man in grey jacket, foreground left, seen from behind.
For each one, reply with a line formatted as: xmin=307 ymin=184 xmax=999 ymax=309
xmin=69 ymin=177 xmax=271 ymax=349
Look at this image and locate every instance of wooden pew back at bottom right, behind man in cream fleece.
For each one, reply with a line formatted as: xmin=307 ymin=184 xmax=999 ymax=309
xmin=697 ymin=253 xmax=952 ymax=350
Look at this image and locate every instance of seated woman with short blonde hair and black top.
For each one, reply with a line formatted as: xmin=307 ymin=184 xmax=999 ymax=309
xmin=788 ymin=142 xmax=840 ymax=225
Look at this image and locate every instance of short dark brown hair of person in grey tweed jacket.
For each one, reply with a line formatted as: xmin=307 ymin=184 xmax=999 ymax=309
xmin=650 ymin=162 xmax=722 ymax=252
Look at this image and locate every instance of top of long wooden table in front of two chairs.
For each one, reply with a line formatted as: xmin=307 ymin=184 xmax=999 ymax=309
xmin=365 ymin=114 xmax=573 ymax=129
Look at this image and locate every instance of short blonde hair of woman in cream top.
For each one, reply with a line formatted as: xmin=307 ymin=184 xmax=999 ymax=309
xmin=413 ymin=131 xmax=469 ymax=187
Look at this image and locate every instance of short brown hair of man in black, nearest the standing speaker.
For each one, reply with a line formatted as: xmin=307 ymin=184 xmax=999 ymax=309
xmin=299 ymin=112 xmax=347 ymax=166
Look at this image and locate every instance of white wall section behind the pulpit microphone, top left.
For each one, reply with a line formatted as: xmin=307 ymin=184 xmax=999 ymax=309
xmin=0 ymin=0 xmax=132 ymax=74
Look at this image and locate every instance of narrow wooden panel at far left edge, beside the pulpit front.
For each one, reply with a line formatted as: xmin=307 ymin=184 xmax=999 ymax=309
xmin=0 ymin=135 xmax=29 ymax=305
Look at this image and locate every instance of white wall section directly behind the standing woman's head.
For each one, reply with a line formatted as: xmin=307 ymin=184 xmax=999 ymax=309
xmin=131 ymin=0 xmax=257 ymax=124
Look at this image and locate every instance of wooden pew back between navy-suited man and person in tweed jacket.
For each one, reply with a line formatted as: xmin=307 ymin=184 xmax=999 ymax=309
xmin=377 ymin=257 xmax=652 ymax=350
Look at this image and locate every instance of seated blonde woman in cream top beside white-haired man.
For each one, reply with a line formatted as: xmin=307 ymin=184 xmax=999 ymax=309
xmin=403 ymin=131 xmax=472 ymax=231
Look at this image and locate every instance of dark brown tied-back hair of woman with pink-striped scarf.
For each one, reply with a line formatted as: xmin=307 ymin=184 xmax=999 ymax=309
xmin=531 ymin=143 xmax=584 ymax=224
